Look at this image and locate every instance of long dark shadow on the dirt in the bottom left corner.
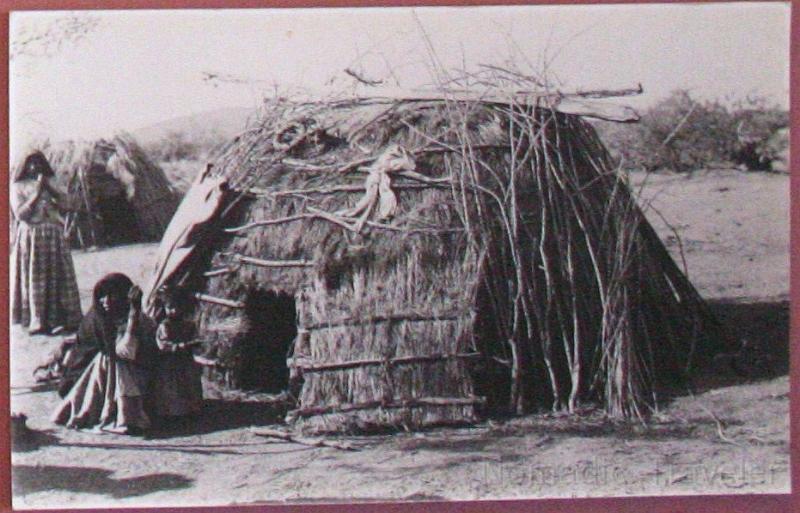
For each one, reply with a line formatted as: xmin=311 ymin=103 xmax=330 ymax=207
xmin=12 ymin=465 xmax=192 ymax=499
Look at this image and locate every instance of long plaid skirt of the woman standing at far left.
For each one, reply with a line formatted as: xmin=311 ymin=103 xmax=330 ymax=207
xmin=11 ymin=223 xmax=81 ymax=331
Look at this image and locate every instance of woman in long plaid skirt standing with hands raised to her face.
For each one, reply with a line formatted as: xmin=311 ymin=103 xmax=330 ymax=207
xmin=9 ymin=151 xmax=81 ymax=334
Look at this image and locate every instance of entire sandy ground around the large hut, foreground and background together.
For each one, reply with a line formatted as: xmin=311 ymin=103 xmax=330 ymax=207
xmin=11 ymin=171 xmax=789 ymax=508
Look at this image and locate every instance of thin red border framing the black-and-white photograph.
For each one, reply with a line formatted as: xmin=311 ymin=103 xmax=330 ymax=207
xmin=0 ymin=0 xmax=800 ymax=513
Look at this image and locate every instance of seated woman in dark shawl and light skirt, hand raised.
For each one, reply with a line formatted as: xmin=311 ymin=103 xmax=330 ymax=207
xmin=53 ymin=273 xmax=155 ymax=434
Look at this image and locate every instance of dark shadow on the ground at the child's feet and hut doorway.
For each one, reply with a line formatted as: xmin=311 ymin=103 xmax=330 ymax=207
xmin=148 ymin=399 xmax=288 ymax=439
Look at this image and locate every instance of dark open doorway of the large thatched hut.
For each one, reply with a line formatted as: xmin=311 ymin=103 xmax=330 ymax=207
xmin=240 ymin=289 xmax=297 ymax=393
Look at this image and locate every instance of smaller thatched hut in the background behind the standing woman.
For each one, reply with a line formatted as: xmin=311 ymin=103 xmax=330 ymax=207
xmin=36 ymin=135 xmax=180 ymax=247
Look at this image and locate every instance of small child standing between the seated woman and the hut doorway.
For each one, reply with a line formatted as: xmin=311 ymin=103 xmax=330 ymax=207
xmin=153 ymin=290 xmax=203 ymax=417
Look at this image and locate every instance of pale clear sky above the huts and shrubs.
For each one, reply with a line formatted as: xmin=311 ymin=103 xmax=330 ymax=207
xmin=10 ymin=3 xmax=790 ymax=158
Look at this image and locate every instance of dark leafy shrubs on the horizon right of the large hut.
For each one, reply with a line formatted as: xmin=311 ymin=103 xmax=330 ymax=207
xmin=598 ymin=90 xmax=788 ymax=172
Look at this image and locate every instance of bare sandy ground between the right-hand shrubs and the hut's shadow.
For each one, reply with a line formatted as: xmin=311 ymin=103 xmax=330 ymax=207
xmin=631 ymin=170 xmax=789 ymax=299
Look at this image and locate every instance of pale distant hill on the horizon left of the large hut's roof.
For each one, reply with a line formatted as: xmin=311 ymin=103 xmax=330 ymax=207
xmin=132 ymin=107 xmax=256 ymax=146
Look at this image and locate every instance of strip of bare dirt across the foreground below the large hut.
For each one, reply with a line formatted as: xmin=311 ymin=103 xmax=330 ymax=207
xmin=13 ymin=360 xmax=789 ymax=507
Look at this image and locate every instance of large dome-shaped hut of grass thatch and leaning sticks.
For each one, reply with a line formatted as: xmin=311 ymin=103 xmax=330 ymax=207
xmin=145 ymin=85 xmax=724 ymax=430
